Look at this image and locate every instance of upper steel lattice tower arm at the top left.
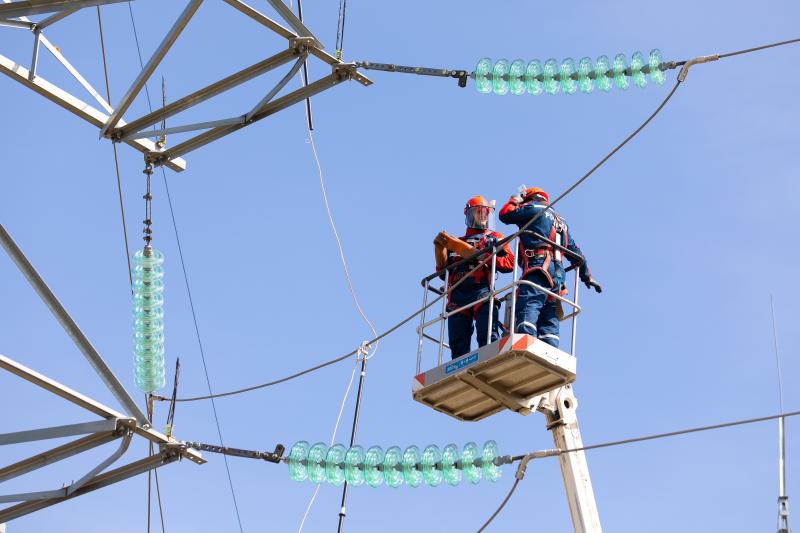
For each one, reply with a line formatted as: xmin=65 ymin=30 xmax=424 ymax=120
xmin=0 ymin=0 xmax=372 ymax=171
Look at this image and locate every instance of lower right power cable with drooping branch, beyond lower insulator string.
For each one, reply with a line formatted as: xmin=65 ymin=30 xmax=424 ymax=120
xmin=478 ymin=411 xmax=800 ymax=533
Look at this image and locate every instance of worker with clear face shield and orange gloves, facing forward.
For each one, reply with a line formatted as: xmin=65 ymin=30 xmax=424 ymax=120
xmin=433 ymin=196 xmax=514 ymax=359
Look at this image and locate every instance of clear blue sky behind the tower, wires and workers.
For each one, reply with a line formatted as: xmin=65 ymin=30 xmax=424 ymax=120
xmin=0 ymin=0 xmax=800 ymax=533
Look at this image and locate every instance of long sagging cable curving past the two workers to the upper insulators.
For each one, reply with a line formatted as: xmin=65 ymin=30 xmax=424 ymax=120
xmin=164 ymin=76 xmax=680 ymax=402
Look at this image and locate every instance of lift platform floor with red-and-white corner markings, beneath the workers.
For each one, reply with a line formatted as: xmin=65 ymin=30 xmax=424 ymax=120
xmin=412 ymin=333 xmax=575 ymax=421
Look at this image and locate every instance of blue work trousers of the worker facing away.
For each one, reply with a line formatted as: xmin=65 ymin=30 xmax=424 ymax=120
xmin=515 ymin=271 xmax=559 ymax=348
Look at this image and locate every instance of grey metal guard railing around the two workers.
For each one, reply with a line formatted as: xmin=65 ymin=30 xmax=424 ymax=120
xmin=416 ymin=230 xmax=584 ymax=374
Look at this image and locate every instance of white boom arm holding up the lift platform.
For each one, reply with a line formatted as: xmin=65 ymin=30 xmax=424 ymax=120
xmin=539 ymin=385 xmax=603 ymax=533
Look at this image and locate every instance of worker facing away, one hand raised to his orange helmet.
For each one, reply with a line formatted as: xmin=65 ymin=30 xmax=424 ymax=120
xmin=500 ymin=187 xmax=603 ymax=348
